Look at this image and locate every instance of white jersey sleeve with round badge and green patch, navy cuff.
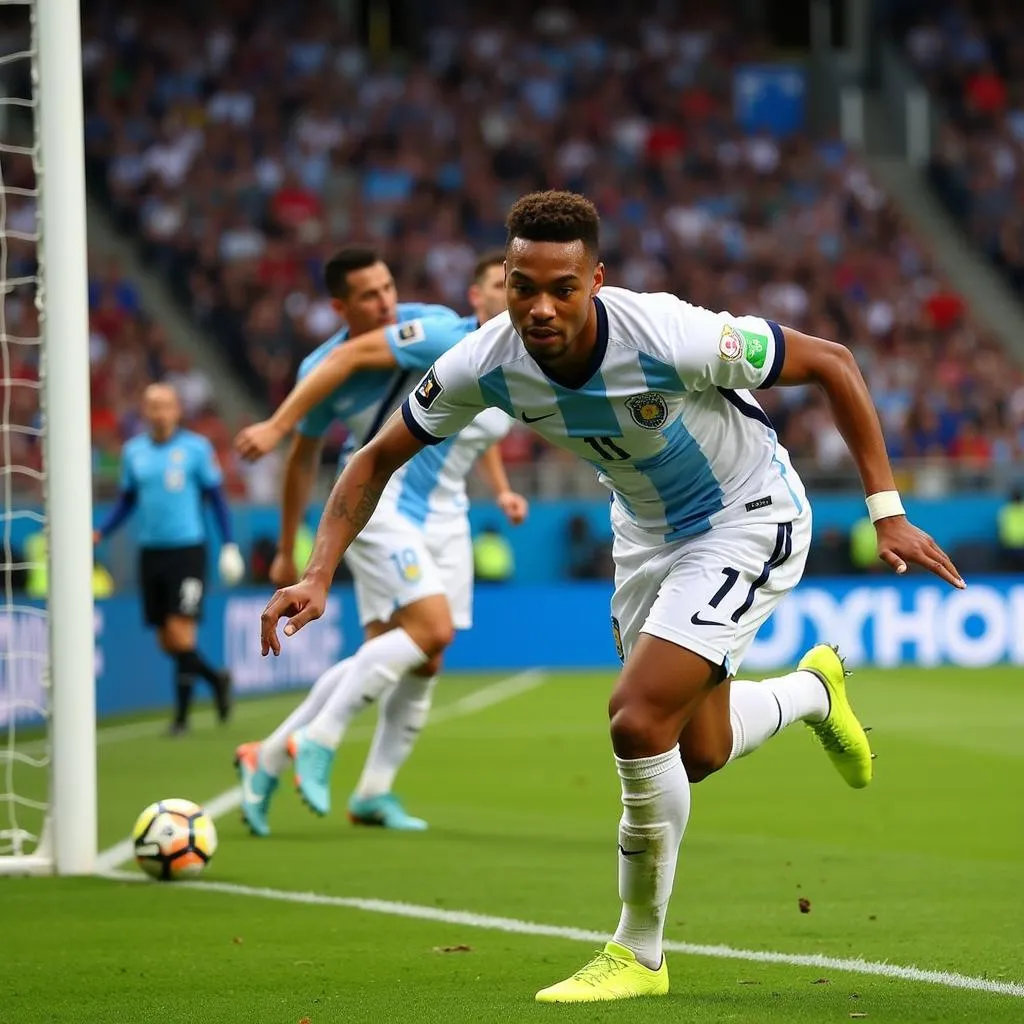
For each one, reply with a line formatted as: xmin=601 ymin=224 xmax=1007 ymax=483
xmin=673 ymin=302 xmax=785 ymax=391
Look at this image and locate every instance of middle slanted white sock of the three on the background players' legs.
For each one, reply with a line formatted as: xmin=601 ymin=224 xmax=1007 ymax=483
xmin=306 ymin=629 xmax=427 ymax=750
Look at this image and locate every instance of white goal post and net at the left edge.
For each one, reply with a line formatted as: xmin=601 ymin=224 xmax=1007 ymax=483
xmin=0 ymin=0 xmax=95 ymax=873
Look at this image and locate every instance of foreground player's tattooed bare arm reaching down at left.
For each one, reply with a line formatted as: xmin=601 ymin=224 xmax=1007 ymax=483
xmin=260 ymin=413 xmax=424 ymax=656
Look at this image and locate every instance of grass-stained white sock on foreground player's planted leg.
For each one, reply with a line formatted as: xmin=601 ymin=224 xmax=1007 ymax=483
xmin=614 ymin=746 xmax=690 ymax=970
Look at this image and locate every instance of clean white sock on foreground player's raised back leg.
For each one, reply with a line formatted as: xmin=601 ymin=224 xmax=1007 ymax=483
xmin=729 ymin=672 xmax=828 ymax=761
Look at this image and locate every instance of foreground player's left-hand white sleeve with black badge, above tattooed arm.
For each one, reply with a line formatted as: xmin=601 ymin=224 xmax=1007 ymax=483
xmin=401 ymin=345 xmax=487 ymax=444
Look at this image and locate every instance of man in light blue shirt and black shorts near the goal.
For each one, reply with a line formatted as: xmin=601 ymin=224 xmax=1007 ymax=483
xmin=93 ymin=384 xmax=245 ymax=735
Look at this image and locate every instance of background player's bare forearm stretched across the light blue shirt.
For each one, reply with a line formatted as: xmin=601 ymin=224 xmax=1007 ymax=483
xmin=234 ymin=329 xmax=398 ymax=461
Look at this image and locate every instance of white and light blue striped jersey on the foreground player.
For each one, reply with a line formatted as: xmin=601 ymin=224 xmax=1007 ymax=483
xmin=402 ymin=288 xmax=807 ymax=541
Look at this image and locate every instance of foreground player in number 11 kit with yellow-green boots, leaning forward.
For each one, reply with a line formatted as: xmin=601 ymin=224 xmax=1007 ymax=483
xmin=262 ymin=193 xmax=965 ymax=1002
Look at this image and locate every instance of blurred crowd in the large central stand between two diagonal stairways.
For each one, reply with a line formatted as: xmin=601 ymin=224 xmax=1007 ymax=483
xmin=72 ymin=0 xmax=1024 ymax=485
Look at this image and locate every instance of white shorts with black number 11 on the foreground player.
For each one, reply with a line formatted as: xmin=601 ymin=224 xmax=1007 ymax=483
xmin=611 ymin=508 xmax=811 ymax=676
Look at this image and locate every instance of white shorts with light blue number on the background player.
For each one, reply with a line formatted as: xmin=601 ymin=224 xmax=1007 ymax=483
xmin=345 ymin=506 xmax=473 ymax=630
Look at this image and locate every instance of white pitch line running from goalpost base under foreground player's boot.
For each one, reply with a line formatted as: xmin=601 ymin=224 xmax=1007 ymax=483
xmin=94 ymin=871 xmax=1024 ymax=998
